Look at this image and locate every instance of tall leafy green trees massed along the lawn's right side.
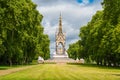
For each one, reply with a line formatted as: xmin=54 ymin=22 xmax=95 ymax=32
xmin=68 ymin=0 xmax=120 ymax=66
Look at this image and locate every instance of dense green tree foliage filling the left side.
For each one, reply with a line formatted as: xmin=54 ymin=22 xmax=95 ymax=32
xmin=0 ymin=0 xmax=50 ymax=65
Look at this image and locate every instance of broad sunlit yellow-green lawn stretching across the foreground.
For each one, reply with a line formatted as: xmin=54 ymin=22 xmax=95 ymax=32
xmin=0 ymin=64 xmax=120 ymax=80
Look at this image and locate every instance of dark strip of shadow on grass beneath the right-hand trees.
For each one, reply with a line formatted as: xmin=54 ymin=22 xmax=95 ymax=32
xmin=67 ymin=63 xmax=120 ymax=70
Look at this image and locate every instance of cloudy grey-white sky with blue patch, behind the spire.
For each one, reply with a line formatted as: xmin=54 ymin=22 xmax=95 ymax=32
xmin=32 ymin=0 xmax=102 ymax=53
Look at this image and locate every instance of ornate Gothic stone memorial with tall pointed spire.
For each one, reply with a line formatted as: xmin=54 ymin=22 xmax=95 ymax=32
xmin=52 ymin=14 xmax=68 ymax=59
